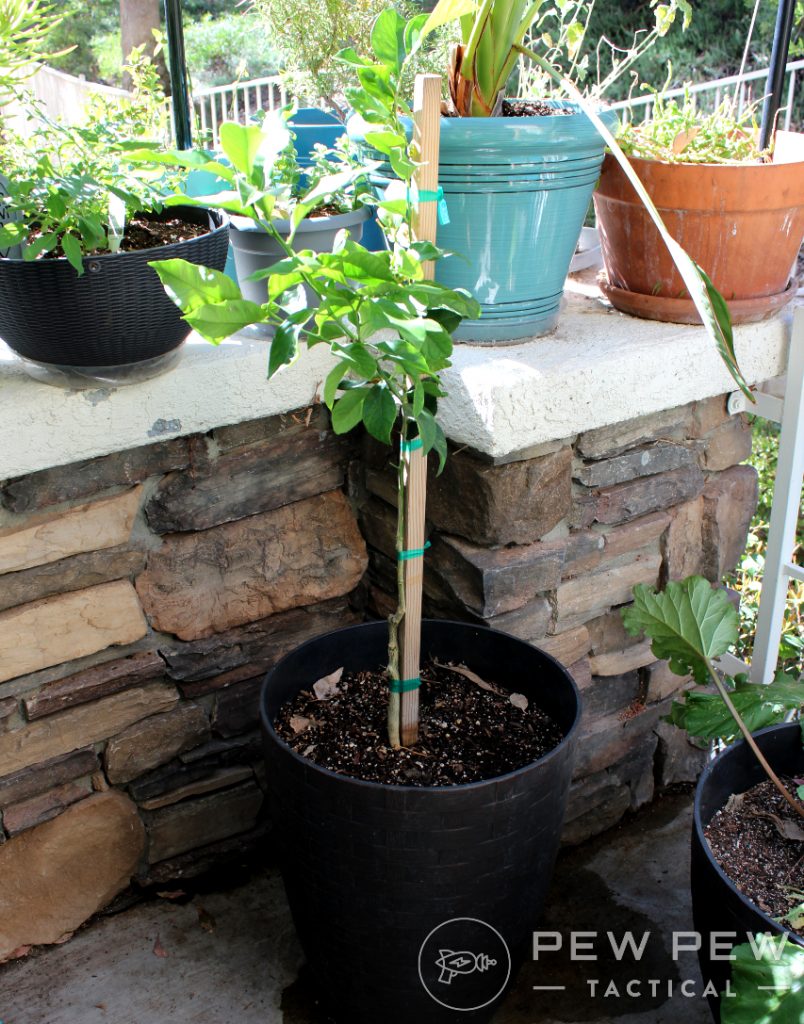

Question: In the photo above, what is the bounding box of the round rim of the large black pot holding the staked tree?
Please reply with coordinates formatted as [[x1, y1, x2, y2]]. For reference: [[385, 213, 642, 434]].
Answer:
[[259, 618, 582, 794]]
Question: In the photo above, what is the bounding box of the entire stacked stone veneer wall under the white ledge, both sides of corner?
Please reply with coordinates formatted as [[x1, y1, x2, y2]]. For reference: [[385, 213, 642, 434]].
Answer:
[[0, 391, 756, 959]]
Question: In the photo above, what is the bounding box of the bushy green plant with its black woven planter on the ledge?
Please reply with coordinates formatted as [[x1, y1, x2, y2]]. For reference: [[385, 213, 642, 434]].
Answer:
[[0, 45, 227, 384]]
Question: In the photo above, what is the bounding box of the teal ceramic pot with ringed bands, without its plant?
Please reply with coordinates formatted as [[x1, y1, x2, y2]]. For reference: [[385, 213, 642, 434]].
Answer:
[[347, 104, 617, 342]]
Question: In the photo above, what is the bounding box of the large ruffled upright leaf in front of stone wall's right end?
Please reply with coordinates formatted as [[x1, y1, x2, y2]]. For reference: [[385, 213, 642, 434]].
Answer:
[[623, 577, 739, 683]]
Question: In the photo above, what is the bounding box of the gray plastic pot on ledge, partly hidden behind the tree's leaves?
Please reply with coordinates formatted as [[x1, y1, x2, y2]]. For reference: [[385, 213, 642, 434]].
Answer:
[[229, 206, 371, 305]]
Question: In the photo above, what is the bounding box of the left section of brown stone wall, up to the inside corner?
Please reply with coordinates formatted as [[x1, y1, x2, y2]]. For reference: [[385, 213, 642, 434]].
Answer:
[[0, 407, 367, 959]]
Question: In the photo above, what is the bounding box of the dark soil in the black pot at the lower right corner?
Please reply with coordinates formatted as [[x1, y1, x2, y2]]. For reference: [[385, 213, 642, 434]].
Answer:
[[705, 777, 804, 938]]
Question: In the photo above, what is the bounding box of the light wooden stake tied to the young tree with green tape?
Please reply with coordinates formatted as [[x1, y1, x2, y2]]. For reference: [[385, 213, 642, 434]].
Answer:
[[399, 75, 441, 746]]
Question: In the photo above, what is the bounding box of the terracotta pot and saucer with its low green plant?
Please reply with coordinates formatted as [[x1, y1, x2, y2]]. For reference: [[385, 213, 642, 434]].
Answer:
[[594, 93, 804, 324]]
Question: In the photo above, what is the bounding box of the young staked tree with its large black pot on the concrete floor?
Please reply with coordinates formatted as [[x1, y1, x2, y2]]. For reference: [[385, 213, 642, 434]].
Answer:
[[147, 46, 580, 1024]]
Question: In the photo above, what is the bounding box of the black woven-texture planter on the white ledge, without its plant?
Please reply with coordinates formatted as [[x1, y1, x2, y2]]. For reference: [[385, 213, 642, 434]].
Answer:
[[0, 207, 228, 367]]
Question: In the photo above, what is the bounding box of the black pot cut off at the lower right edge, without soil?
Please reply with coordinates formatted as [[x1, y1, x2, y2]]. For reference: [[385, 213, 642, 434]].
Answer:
[[691, 722, 804, 1022]]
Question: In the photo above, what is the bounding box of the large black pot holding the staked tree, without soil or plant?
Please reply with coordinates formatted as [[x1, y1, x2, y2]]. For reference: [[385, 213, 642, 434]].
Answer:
[[260, 621, 580, 1024]]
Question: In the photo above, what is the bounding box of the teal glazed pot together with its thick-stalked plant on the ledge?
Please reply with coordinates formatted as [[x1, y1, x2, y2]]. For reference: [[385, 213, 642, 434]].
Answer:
[[344, 0, 689, 342]]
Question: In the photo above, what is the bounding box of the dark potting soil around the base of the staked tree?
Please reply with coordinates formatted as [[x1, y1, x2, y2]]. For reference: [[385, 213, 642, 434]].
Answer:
[[276, 665, 563, 786]]
